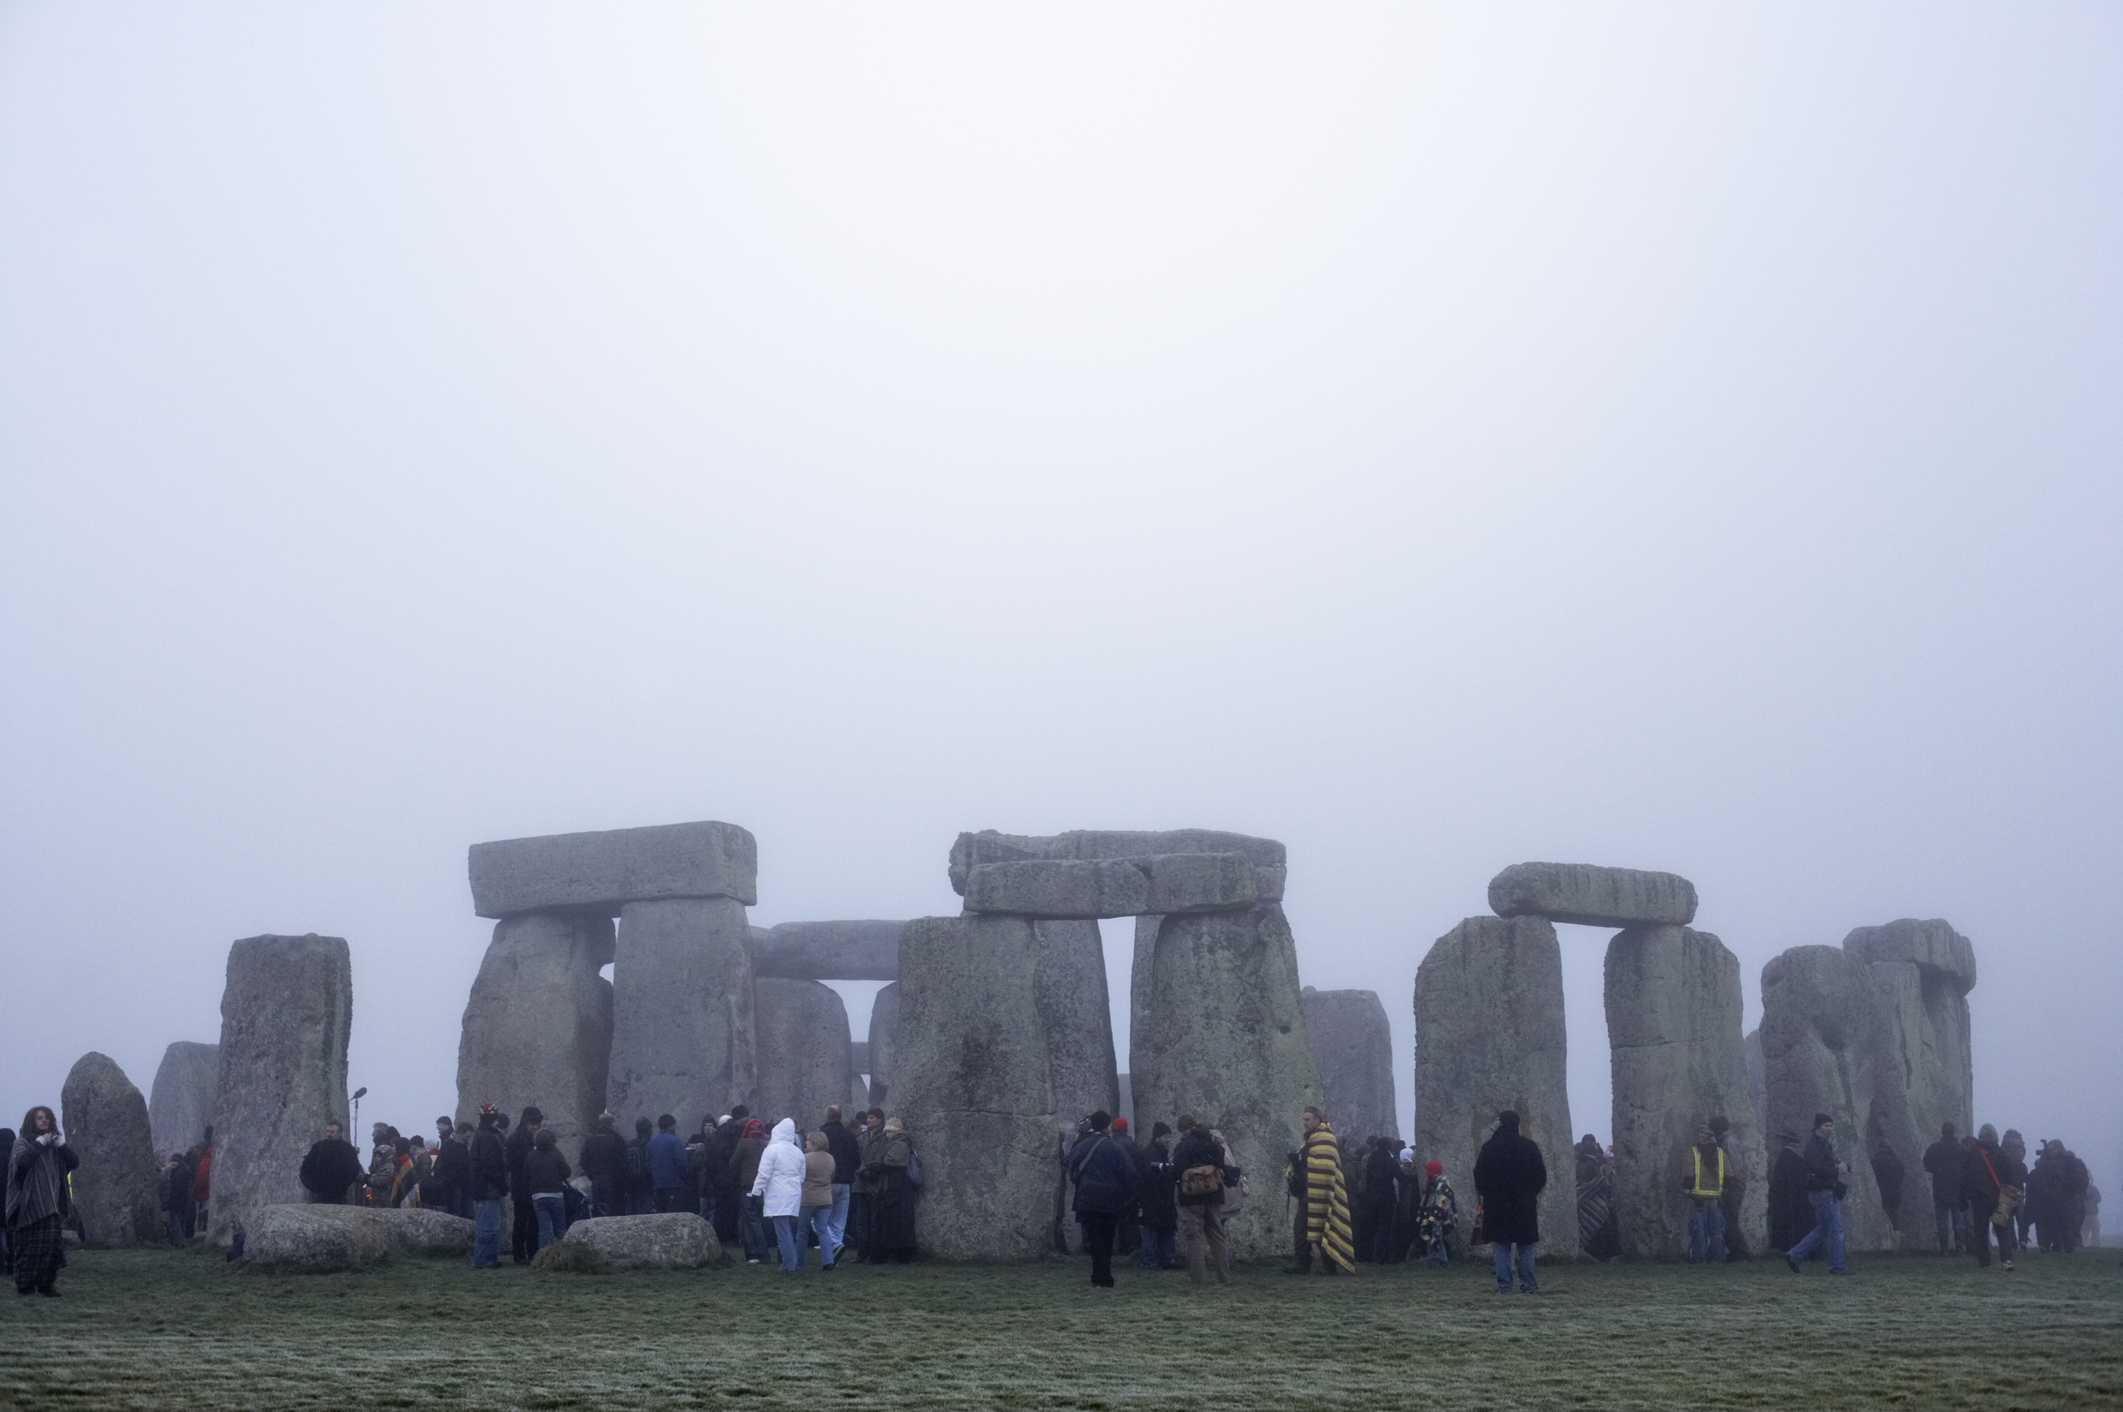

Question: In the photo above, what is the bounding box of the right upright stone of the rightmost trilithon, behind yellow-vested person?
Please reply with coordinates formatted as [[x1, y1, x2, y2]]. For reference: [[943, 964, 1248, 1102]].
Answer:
[[1607, 926, 1768, 1259]]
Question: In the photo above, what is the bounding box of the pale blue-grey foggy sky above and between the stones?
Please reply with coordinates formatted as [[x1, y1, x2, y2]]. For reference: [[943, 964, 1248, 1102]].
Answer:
[[0, 4, 2123, 1191]]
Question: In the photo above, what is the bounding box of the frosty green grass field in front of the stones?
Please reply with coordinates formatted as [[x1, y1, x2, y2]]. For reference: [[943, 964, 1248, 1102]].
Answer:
[[0, 1249, 2123, 1412]]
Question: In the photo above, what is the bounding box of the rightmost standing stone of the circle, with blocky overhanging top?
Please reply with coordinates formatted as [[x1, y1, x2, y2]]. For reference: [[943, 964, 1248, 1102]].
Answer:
[[1843, 917, 1977, 1155]]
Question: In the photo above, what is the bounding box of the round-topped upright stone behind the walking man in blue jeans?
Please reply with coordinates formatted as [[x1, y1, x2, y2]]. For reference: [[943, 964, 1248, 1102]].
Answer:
[[1762, 947, 1936, 1251]]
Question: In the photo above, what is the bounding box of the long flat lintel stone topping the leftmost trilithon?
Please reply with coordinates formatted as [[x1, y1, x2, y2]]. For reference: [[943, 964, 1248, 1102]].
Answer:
[[469, 820, 760, 917]]
